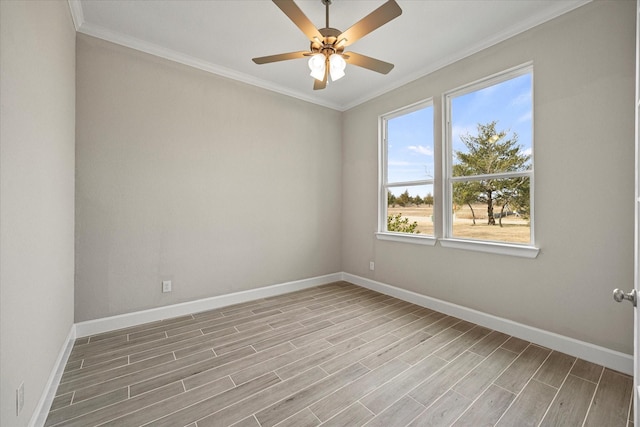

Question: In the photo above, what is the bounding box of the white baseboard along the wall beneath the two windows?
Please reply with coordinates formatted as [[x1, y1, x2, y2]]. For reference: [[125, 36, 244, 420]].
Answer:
[[342, 273, 633, 375]]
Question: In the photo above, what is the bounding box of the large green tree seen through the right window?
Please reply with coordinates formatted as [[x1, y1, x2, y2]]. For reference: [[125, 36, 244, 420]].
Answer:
[[453, 121, 531, 225]]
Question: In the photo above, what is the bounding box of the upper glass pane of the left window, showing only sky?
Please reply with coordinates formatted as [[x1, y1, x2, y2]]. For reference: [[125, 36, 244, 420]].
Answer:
[[387, 106, 434, 183]]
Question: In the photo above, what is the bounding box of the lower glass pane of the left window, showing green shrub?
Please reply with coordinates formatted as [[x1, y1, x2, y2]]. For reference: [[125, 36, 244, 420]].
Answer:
[[387, 185, 433, 236]]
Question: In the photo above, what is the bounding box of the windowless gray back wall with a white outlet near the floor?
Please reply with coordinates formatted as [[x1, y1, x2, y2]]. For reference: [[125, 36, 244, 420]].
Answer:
[[75, 34, 342, 321]]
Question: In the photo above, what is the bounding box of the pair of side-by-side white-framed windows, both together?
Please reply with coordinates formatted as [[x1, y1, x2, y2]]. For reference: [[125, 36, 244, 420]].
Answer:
[[377, 64, 538, 257]]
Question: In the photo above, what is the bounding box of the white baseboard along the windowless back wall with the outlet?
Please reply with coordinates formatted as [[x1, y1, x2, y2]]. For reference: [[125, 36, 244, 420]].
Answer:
[[76, 273, 342, 338]]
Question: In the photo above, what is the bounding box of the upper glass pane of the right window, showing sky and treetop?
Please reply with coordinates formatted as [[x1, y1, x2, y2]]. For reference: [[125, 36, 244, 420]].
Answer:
[[451, 73, 533, 176]]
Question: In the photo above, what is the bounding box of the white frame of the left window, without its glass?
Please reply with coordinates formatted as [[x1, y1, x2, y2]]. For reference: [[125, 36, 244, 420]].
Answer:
[[376, 98, 438, 246]]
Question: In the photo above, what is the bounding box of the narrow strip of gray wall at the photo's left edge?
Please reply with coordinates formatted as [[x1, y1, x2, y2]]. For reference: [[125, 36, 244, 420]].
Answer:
[[0, 1, 75, 427]]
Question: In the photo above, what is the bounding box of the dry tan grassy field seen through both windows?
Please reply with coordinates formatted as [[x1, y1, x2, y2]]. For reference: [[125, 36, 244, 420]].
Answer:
[[388, 205, 531, 243]]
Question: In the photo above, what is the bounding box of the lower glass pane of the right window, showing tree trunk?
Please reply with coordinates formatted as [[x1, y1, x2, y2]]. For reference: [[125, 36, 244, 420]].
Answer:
[[452, 177, 531, 244]]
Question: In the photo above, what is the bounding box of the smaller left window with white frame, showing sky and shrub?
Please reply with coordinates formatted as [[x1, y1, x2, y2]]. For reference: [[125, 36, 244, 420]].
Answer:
[[379, 101, 435, 243]]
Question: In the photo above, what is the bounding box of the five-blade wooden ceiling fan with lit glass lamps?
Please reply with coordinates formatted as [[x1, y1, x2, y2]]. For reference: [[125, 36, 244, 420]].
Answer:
[[253, 0, 402, 90]]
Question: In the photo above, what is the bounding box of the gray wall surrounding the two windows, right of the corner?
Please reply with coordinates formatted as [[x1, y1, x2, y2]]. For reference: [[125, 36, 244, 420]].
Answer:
[[342, 1, 635, 354]]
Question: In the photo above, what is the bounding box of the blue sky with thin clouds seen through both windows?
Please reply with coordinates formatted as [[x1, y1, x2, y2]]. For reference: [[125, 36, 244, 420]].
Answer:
[[387, 73, 533, 197]]
